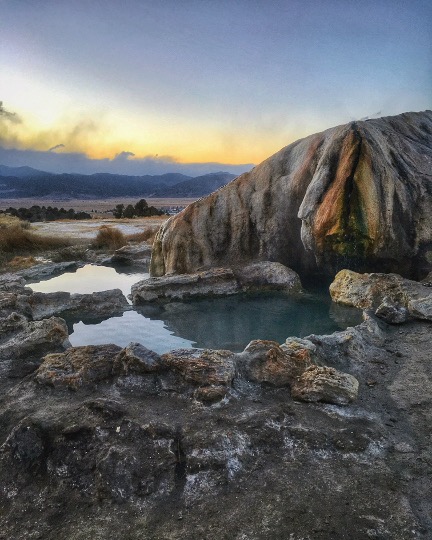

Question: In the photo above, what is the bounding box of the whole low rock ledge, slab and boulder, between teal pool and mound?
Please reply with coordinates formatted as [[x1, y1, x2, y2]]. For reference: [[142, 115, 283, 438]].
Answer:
[[131, 261, 301, 304]]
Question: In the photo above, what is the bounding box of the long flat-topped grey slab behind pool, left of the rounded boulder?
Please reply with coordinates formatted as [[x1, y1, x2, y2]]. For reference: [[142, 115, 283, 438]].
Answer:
[[131, 268, 240, 305]]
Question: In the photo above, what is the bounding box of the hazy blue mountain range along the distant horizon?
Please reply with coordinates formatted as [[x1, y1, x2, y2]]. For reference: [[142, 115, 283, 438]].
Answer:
[[0, 165, 235, 199]]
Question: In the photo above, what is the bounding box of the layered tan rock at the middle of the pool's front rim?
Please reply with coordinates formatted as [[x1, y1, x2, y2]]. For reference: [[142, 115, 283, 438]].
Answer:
[[161, 349, 234, 387]]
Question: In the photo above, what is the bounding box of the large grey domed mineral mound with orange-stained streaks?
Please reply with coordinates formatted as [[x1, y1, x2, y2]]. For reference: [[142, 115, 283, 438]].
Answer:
[[151, 111, 432, 276]]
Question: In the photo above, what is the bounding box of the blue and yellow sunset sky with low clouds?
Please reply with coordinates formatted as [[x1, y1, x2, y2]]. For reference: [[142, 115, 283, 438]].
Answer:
[[0, 0, 432, 174]]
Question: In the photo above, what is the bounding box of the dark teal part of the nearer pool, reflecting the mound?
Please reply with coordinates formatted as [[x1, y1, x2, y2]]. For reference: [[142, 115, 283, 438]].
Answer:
[[139, 293, 361, 351]]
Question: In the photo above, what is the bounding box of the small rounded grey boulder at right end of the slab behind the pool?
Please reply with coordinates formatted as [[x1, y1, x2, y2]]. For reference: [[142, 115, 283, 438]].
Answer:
[[234, 261, 302, 292]]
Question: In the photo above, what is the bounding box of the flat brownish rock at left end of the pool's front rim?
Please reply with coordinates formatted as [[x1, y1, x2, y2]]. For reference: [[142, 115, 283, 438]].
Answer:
[[35, 345, 121, 390]]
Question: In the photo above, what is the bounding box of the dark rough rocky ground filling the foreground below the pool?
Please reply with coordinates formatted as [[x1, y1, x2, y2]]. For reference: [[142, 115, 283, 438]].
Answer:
[[0, 317, 432, 540]]
